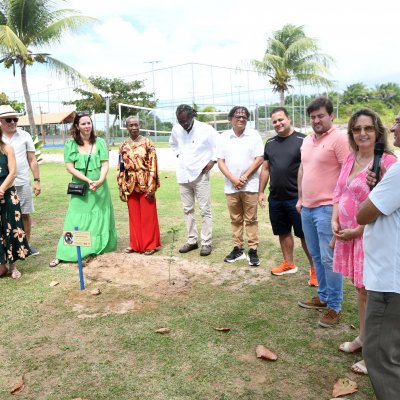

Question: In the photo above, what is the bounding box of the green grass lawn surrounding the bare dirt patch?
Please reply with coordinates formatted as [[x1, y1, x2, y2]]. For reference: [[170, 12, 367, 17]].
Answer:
[[0, 163, 374, 400]]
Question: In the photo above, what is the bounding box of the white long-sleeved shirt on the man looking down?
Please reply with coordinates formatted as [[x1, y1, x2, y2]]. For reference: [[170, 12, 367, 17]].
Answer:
[[169, 120, 218, 183]]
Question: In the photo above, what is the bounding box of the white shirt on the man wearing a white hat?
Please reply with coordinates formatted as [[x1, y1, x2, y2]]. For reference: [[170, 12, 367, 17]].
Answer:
[[3, 128, 35, 186]]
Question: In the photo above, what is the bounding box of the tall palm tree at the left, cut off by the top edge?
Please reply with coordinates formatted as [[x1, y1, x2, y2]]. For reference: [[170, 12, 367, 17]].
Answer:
[[0, 0, 96, 135]]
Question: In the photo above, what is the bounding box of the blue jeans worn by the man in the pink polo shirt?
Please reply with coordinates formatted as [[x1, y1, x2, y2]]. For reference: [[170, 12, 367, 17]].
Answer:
[[301, 205, 343, 312]]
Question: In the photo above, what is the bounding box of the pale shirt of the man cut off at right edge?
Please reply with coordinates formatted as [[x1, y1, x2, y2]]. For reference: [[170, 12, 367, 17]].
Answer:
[[363, 162, 400, 294]]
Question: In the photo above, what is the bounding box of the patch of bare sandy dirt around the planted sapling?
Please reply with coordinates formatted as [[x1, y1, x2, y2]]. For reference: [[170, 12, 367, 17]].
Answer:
[[69, 253, 270, 318]]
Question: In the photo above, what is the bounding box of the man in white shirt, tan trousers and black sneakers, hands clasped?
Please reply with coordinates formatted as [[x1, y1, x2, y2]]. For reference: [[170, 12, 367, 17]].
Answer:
[[217, 106, 264, 267]]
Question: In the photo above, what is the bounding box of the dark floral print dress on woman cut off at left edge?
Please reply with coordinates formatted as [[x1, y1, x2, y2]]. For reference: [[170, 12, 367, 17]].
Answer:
[[0, 152, 30, 264]]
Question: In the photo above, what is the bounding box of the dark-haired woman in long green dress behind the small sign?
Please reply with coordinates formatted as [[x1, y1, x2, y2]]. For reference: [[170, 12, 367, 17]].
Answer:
[[50, 113, 117, 267]]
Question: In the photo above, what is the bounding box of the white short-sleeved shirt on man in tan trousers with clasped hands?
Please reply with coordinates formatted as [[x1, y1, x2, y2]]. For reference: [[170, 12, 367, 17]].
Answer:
[[217, 127, 264, 194]]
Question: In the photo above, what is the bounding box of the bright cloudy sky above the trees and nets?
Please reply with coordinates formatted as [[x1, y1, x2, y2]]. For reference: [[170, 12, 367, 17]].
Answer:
[[0, 0, 400, 112]]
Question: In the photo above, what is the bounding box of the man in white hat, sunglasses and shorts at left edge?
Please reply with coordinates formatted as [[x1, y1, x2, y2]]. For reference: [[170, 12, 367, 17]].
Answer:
[[0, 105, 40, 256]]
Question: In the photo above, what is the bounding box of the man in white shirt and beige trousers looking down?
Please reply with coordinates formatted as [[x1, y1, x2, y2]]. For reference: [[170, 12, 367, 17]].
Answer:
[[169, 104, 218, 256]]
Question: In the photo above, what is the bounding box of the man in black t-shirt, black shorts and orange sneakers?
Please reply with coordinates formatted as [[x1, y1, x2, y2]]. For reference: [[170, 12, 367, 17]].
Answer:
[[258, 107, 318, 286]]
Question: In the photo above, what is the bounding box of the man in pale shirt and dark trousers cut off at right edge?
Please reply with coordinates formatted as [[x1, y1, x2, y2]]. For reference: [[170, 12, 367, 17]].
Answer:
[[357, 113, 400, 400]]
